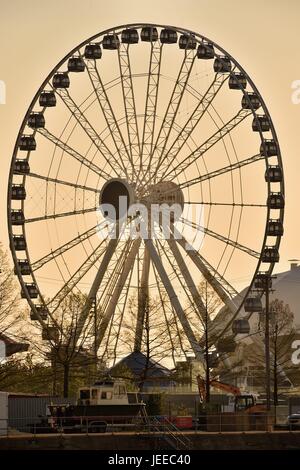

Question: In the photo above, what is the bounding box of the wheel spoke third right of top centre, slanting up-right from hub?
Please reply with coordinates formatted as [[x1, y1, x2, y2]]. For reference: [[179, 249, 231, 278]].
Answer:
[[156, 73, 229, 179]]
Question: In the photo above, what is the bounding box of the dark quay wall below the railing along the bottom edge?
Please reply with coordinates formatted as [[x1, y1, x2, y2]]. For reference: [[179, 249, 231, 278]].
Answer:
[[0, 431, 300, 451]]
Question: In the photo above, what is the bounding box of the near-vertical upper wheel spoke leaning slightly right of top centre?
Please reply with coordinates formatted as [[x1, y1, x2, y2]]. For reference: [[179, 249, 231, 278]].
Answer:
[[140, 41, 163, 168]]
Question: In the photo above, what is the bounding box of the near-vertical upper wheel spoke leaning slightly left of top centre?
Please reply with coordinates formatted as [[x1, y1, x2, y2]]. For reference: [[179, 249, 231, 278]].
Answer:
[[118, 43, 141, 166]]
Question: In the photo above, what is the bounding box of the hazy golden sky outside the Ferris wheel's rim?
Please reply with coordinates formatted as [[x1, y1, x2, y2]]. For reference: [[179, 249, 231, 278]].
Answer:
[[0, 0, 300, 282]]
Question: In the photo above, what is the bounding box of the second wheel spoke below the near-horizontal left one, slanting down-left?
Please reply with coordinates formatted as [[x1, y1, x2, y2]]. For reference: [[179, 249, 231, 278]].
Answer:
[[47, 239, 107, 314]]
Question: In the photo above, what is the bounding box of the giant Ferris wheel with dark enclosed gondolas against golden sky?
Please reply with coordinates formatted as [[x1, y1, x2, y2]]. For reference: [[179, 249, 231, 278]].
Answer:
[[7, 24, 284, 366]]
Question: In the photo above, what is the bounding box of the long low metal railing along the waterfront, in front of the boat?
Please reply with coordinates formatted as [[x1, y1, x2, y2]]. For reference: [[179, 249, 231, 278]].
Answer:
[[0, 413, 300, 438]]
